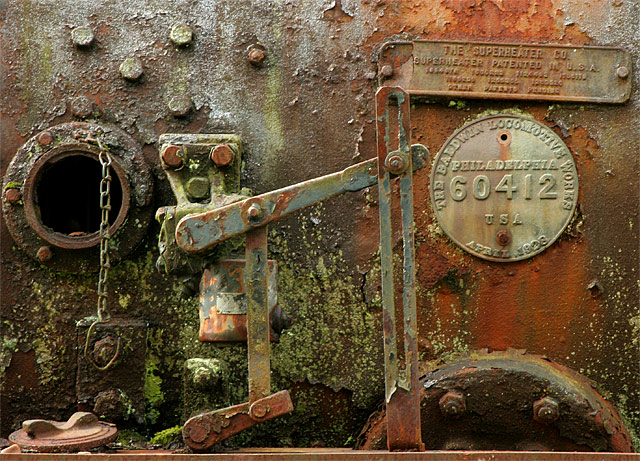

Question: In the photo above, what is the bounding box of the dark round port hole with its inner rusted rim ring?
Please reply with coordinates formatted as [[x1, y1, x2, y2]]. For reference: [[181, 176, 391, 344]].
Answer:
[[25, 150, 129, 248]]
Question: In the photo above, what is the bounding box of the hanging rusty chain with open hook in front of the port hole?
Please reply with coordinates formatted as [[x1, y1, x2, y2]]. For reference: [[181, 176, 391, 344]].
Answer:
[[84, 134, 120, 371]]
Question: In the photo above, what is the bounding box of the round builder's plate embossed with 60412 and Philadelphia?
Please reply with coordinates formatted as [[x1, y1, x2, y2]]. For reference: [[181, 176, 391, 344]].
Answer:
[[431, 114, 578, 262]]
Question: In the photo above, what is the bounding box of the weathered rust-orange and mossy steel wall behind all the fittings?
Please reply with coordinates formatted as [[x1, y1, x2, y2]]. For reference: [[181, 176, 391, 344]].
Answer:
[[0, 0, 640, 446]]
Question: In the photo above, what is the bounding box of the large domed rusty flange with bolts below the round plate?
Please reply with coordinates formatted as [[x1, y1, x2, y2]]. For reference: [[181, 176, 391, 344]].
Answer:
[[361, 350, 634, 453]]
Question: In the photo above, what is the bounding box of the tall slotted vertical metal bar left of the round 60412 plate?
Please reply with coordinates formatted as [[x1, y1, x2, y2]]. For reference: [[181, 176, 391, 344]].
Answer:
[[376, 87, 424, 450]]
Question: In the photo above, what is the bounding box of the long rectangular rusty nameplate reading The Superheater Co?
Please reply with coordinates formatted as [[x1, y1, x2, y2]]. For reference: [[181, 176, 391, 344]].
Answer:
[[379, 40, 632, 103]]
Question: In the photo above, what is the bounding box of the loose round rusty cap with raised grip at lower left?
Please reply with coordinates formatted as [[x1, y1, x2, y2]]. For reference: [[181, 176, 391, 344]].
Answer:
[[9, 412, 118, 453]]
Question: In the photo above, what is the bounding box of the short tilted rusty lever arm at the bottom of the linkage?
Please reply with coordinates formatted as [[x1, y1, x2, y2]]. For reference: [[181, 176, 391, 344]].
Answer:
[[182, 390, 293, 451]]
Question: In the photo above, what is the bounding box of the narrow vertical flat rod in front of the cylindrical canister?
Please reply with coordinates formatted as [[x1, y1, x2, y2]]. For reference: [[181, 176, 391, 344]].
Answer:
[[244, 225, 271, 403]]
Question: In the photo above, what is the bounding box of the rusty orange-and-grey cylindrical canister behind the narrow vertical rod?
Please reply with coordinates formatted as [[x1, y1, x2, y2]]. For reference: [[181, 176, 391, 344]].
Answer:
[[198, 259, 282, 341]]
